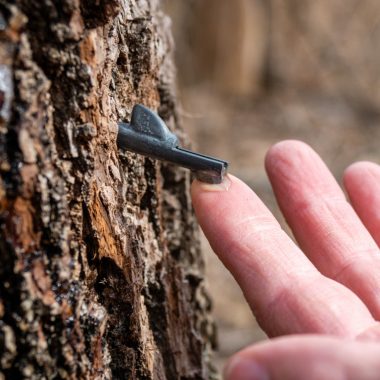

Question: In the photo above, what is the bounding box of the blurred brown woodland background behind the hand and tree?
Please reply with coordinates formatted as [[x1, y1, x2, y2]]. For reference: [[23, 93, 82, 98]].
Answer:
[[163, 0, 380, 372]]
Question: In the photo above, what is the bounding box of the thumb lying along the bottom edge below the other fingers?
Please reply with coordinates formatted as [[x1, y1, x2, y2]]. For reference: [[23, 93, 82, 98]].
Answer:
[[225, 335, 380, 380]]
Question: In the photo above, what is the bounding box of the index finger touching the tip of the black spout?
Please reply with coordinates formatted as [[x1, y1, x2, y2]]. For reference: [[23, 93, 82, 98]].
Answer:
[[192, 176, 374, 336]]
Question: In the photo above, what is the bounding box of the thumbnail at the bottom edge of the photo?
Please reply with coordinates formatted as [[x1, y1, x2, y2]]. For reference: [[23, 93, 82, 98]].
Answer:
[[223, 356, 270, 380]]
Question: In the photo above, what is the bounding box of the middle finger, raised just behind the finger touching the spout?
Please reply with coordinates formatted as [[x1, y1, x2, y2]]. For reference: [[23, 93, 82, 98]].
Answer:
[[266, 141, 380, 320]]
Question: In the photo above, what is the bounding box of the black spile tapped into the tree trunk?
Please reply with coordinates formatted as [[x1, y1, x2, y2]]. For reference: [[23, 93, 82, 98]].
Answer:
[[117, 104, 228, 183]]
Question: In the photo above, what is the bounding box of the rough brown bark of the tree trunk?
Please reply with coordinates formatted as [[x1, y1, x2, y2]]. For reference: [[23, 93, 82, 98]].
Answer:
[[0, 0, 214, 379]]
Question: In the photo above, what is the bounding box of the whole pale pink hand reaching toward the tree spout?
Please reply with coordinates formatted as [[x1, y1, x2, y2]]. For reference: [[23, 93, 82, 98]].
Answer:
[[192, 141, 380, 380]]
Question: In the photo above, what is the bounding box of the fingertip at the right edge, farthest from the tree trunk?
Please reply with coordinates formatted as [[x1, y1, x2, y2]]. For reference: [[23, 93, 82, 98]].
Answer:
[[344, 162, 380, 246]]
